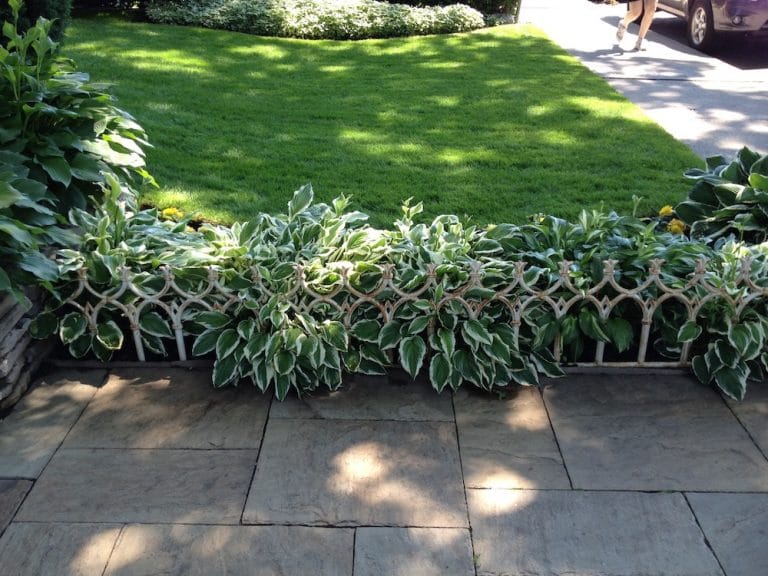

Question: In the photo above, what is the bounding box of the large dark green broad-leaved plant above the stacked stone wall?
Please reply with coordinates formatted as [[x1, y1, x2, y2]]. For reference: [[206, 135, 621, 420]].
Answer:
[[0, 0, 151, 299]]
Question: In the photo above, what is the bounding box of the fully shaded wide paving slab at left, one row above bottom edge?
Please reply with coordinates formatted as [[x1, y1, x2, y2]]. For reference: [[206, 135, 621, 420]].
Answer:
[[17, 448, 256, 524]]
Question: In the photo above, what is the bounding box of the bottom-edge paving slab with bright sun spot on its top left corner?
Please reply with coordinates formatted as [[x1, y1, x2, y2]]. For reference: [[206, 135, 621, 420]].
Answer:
[[467, 489, 724, 576]]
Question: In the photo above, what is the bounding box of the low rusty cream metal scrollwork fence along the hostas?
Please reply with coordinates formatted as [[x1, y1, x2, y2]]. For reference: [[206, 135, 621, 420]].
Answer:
[[64, 259, 768, 368]]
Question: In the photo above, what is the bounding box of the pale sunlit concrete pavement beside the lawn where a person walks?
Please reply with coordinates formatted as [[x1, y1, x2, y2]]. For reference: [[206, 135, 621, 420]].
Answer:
[[520, 0, 768, 158]]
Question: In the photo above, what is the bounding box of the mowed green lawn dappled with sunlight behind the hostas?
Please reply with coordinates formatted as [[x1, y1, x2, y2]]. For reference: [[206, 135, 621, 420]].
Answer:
[[65, 19, 701, 225]]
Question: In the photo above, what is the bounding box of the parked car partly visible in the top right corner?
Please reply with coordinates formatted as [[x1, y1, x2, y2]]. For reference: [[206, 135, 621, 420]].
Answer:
[[659, 0, 768, 52]]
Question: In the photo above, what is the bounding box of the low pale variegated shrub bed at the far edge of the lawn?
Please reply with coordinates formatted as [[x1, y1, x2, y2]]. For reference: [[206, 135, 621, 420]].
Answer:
[[147, 0, 485, 40]]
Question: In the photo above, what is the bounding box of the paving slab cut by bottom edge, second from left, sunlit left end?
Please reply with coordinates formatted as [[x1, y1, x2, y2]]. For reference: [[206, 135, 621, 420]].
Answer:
[[105, 525, 354, 576]]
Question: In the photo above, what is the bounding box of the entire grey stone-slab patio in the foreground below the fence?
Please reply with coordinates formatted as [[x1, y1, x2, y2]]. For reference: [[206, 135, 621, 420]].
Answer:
[[0, 368, 768, 576]]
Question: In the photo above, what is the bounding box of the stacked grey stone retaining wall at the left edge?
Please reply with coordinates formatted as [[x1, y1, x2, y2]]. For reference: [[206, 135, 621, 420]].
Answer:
[[0, 291, 51, 412]]
